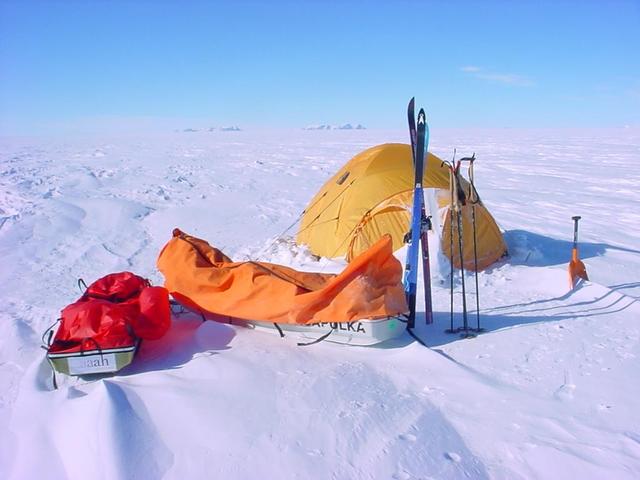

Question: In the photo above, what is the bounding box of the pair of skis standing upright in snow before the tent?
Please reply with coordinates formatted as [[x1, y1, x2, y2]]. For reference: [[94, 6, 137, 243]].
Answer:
[[403, 98, 433, 328]]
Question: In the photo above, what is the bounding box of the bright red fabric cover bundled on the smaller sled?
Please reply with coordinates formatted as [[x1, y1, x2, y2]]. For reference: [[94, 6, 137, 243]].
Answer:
[[49, 272, 171, 353]]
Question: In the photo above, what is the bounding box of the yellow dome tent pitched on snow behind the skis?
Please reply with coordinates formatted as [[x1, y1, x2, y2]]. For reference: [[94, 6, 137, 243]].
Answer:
[[296, 143, 507, 270]]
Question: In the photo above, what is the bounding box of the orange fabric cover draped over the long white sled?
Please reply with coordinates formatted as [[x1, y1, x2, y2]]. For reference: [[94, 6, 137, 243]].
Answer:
[[157, 229, 408, 324]]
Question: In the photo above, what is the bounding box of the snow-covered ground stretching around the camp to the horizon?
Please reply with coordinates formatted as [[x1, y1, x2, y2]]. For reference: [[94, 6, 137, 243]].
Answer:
[[0, 125, 640, 480]]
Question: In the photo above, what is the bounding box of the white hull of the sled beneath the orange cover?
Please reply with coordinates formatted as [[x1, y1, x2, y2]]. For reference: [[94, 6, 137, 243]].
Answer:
[[234, 315, 407, 345]]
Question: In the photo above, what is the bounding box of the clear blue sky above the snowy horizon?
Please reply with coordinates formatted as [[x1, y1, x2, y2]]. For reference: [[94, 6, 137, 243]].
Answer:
[[0, 0, 640, 134]]
